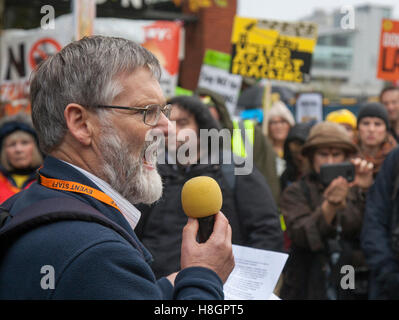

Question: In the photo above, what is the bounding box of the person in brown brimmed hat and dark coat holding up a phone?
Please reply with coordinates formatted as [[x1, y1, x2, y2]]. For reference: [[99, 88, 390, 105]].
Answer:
[[280, 122, 373, 299]]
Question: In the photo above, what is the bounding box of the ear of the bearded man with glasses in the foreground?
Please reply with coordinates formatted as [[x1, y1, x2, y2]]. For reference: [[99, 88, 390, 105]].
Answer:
[[64, 103, 93, 146]]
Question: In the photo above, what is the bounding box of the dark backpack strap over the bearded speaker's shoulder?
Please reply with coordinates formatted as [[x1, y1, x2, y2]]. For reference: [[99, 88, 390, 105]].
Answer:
[[0, 197, 144, 257]]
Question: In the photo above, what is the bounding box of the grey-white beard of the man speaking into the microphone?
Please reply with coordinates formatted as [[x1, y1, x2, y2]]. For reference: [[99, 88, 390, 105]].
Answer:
[[100, 124, 162, 204]]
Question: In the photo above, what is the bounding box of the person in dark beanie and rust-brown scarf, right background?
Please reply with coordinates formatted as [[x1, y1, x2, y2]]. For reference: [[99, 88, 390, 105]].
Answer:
[[355, 103, 397, 176]]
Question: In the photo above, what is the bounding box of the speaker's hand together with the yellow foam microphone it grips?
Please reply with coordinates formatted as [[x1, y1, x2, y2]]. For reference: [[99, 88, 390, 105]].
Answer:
[[180, 176, 234, 283]]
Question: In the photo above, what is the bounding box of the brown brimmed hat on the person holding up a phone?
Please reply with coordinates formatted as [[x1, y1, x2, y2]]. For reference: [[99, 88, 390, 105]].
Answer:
[[302, 121, 358, 156]]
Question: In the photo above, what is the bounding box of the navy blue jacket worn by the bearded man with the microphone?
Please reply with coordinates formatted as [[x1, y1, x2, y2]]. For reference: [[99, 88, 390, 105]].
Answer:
[[0, 157, 223, 300]]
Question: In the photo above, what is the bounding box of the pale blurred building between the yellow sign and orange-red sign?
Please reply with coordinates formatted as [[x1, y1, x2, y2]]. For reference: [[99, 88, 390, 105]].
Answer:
[[301, 5, 392, 97]]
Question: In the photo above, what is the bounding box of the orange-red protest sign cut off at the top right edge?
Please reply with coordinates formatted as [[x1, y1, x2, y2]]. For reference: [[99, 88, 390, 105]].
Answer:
[[377, 19, 399, 81]]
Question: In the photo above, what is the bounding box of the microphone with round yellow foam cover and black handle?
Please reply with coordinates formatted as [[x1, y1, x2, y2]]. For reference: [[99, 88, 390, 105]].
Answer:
[[181, 176, 223, 243]]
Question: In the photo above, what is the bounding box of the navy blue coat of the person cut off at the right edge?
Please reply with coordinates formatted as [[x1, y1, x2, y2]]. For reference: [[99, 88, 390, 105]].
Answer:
[[361, 148, 399, 299]]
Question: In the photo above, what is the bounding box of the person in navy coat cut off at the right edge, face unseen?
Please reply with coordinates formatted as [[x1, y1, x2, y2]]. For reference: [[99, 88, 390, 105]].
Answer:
[[361, 148, 399, 300]]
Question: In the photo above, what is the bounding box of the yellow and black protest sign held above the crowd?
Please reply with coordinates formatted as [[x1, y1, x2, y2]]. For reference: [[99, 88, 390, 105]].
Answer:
[[230, 16, 317, 82]]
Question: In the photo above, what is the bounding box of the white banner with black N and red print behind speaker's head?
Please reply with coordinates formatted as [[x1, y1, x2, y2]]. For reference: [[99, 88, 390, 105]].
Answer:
[[0, 15, 181, 117]]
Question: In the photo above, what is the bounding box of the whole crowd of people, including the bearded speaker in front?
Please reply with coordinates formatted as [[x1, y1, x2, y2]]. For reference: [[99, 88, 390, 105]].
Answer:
[[0, 36, 399, 300]]
